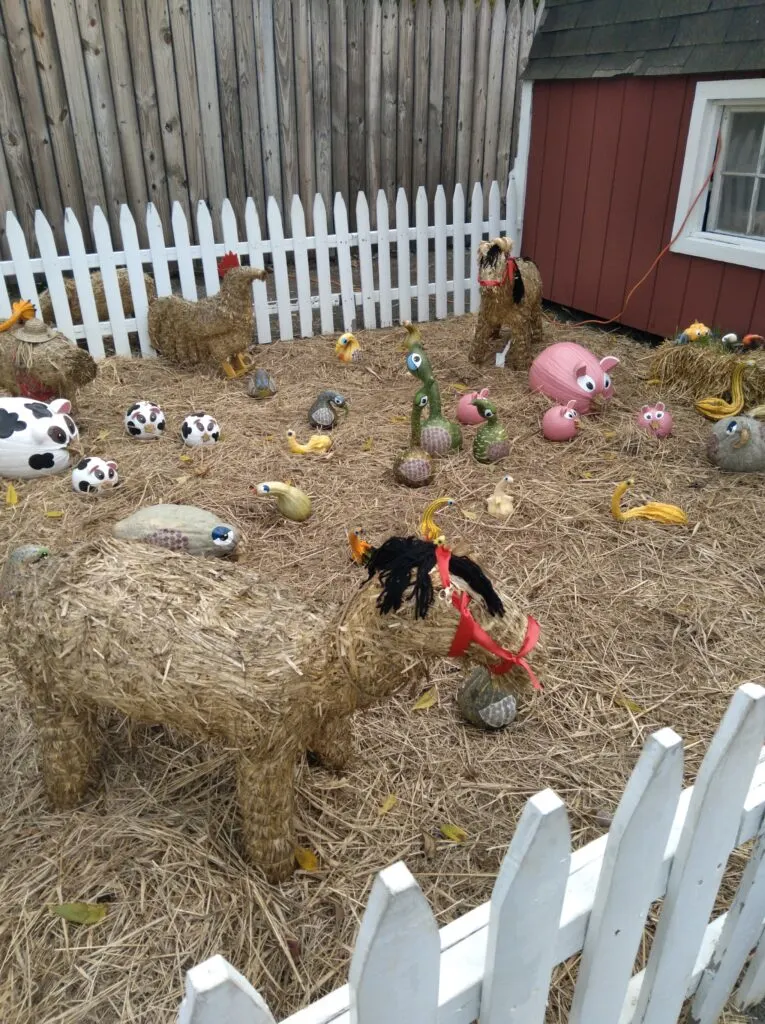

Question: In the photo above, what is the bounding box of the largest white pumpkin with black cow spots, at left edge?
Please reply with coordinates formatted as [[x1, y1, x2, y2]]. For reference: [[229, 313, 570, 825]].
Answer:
[[0, 397, 79, 480]]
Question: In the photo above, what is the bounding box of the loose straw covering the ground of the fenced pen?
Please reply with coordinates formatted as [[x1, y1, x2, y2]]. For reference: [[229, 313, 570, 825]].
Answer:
[[0, 316, 765, 1024]]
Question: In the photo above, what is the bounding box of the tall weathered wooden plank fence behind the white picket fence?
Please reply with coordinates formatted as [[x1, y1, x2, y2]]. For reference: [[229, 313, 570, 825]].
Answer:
[[0, 0, 543, 251]]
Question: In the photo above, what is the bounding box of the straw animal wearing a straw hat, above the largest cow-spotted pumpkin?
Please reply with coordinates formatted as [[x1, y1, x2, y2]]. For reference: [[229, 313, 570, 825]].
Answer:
[[0, 319, 96, 409]]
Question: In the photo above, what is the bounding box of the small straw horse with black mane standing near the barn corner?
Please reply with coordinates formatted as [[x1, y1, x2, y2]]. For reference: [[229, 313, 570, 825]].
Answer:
[[469, 238, 543, 370]]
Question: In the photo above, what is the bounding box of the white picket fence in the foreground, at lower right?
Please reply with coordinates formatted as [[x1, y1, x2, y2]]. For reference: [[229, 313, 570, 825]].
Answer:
[[178, 683, 765, 1024]]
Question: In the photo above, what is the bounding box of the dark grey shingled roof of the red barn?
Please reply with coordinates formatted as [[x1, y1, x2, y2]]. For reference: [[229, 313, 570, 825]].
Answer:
[[524, 0, 765, 79]]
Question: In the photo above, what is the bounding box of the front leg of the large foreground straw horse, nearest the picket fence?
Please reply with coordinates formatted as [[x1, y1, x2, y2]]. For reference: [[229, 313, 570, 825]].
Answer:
[[237, 748, 296, 883]]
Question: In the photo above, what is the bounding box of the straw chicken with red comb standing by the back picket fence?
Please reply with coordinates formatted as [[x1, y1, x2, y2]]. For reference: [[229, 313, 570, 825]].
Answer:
[[148, 266, 268, 368]]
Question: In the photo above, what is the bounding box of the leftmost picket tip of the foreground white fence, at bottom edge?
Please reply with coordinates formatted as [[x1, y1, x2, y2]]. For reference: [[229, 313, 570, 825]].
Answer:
[[178, 954, 273, 1024]]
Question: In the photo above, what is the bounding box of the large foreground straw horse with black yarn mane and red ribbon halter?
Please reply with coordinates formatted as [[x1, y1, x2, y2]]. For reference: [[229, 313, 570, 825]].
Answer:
[[0, 538, 533, 882]]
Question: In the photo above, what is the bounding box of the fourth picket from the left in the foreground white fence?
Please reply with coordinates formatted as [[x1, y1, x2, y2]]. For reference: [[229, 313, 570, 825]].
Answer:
[[568, 729, 683, 1024]]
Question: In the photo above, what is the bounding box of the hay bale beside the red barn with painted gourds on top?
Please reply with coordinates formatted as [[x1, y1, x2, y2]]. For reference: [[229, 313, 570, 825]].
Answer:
[[650, 341, 765, 408]]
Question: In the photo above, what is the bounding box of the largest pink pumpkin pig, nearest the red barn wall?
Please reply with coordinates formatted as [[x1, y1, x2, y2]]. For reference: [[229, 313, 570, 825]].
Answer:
[[528, 341, 619, 415]]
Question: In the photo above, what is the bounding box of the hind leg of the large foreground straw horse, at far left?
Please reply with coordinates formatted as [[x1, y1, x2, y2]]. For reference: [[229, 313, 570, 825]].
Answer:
[[33, 693, 100, 810]]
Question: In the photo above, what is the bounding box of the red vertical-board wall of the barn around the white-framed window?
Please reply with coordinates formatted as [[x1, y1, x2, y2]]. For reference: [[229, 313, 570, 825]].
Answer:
[[522, 76, 765, 337]]
